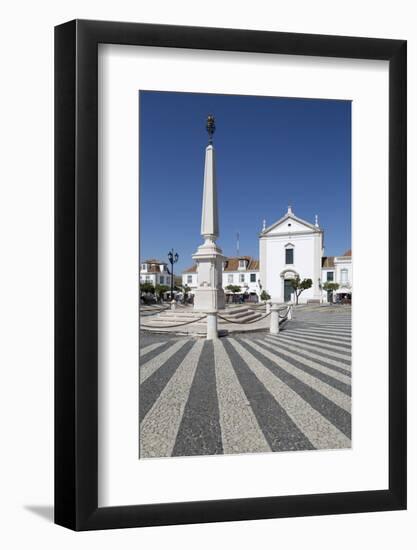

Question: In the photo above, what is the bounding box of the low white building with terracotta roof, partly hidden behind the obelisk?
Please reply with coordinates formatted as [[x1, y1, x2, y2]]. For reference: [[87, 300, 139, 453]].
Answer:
[[182, 256, 260, 296]]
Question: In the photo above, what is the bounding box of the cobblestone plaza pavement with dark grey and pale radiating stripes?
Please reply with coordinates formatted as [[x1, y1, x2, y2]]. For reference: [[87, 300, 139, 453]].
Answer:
[[139, 306, 351, 458]]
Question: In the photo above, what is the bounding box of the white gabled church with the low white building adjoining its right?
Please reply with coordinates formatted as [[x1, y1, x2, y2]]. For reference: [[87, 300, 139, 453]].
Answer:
[[259, 206, 352, 303]]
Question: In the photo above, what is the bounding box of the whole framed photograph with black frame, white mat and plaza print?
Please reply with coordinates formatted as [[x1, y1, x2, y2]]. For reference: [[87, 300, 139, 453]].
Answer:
[[55, 20, 406, 530]]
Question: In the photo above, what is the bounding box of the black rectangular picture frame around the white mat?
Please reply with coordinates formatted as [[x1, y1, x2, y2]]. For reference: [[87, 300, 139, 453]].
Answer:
[[55, 20, 407, 530]]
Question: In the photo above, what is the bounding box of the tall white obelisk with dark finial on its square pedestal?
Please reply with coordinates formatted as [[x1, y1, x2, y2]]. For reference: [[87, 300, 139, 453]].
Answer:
[[193, 115, 225, 312]]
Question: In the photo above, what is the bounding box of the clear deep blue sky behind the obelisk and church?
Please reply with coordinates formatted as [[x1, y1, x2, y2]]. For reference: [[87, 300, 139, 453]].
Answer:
[[139, 91, 351, 273]]
